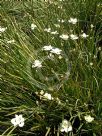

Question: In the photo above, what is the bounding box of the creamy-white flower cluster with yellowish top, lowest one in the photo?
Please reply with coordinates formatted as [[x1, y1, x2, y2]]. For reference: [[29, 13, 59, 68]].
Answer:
[[60, 119, 72, 133]]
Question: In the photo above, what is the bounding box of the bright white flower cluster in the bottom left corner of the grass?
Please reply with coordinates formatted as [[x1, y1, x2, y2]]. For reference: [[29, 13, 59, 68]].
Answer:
[[11, 115, 24, 127]]
